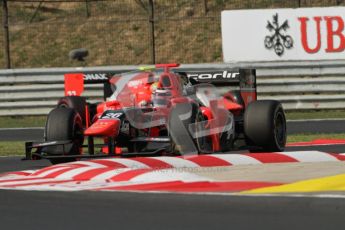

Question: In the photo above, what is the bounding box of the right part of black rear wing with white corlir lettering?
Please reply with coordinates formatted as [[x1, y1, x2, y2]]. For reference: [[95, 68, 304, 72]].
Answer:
[[175, 69, 257, 106]]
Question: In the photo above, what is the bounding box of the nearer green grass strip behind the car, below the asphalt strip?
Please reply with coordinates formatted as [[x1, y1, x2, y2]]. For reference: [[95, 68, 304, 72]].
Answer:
[[0, 133, 345, 157]]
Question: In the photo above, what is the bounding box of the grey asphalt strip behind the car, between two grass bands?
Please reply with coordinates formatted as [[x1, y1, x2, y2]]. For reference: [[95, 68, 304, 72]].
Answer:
[[0, 120, 345, 141]]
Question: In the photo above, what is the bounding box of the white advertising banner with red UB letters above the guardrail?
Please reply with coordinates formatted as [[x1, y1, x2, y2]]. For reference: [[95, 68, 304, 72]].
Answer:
[[222, 7, 345, 62]]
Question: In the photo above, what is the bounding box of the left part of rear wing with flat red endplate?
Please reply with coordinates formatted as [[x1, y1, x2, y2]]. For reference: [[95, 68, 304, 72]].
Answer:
[[64, 73, 113, 100]]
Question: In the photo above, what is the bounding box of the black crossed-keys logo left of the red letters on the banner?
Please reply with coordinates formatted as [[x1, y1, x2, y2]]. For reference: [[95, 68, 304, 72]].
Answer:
[[265, 14, 293, 57]]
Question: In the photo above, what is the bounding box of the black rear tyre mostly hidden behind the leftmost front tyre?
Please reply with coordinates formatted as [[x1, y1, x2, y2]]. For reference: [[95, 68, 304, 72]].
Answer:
[[57, 96, 86, 125]]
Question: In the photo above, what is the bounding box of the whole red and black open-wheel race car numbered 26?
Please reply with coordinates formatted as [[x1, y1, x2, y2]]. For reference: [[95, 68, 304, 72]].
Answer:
[[26, 64, 286, 164]]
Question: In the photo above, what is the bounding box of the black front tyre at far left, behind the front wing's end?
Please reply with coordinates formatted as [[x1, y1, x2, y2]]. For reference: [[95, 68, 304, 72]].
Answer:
[[45, 108, 84, 164]]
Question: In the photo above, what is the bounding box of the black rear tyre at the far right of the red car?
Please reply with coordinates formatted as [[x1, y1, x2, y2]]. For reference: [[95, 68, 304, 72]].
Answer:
[[244, 100, 286, 152]]
